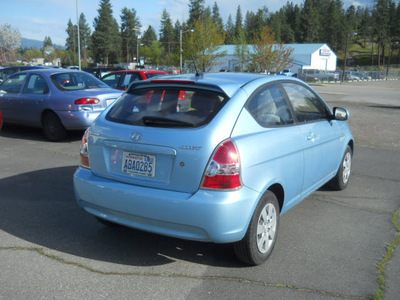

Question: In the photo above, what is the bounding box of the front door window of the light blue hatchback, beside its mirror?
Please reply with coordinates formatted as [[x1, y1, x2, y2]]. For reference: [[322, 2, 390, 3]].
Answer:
[[283, 83, 329, 123]]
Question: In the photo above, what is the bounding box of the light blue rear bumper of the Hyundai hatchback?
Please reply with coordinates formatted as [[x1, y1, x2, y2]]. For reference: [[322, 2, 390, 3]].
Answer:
[[74, 168, 260, 243]]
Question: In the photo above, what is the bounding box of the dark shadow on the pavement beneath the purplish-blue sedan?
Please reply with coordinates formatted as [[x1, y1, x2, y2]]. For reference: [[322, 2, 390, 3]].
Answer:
[[0, 124, 84, 142]]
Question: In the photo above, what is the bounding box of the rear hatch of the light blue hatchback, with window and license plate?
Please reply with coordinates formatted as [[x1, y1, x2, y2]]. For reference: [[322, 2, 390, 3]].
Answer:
[[89, 84, 239, 193]]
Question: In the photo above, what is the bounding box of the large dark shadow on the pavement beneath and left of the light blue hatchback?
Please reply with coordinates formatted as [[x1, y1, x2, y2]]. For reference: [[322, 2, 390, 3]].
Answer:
[[0, 166, 244, 268]]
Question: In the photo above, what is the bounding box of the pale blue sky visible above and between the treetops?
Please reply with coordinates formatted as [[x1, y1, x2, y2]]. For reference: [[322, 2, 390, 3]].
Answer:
[[0, 0, 380, 46]]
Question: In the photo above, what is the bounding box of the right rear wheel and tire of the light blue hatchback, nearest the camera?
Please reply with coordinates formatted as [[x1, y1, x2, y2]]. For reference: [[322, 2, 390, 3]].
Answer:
[[233, 191, 279, 266]]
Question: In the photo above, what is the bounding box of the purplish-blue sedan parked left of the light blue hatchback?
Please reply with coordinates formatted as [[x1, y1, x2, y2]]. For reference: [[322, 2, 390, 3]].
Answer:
[[0, 69, 122, 141]]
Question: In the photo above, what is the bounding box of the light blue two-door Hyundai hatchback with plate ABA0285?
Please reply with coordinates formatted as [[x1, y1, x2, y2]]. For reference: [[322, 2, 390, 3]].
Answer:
[[74, 73, 354, 265]]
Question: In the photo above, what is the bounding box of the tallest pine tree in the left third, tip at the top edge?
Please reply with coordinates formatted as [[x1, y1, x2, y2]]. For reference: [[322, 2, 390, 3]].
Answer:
[[92, 0, 121, 65]]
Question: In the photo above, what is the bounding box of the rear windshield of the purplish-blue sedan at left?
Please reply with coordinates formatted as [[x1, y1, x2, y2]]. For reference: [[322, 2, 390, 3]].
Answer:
[[50, 72, 109, 91]]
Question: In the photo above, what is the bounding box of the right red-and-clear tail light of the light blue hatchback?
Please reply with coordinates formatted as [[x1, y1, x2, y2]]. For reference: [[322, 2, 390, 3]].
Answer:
[[201, 140, 242, 190]]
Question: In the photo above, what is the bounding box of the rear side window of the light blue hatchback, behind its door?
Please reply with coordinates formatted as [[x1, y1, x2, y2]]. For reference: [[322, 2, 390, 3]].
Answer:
[[247, 84, 294, 127]]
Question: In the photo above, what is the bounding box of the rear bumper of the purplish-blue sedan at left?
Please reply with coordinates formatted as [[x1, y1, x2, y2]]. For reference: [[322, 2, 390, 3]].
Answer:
[[57, 110, 102, 130]]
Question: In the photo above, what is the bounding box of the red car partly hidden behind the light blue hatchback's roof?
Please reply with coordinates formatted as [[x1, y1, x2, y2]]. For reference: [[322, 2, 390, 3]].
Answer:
[[101, 70, 169, 90]]
